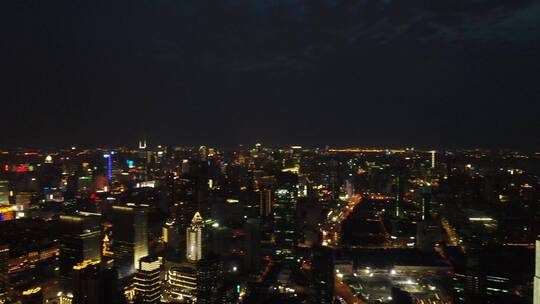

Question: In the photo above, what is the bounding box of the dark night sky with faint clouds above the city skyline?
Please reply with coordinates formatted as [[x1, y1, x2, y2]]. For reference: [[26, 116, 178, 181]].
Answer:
[[0, 0, 540, 149]]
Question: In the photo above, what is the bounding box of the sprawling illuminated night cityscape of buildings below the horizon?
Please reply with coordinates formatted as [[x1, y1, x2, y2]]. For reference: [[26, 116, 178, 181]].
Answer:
[[0, 144, 540, 304]]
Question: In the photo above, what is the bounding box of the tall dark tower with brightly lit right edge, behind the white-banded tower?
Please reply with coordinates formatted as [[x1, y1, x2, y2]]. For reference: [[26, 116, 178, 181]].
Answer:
[[111, 206, 148, 278]]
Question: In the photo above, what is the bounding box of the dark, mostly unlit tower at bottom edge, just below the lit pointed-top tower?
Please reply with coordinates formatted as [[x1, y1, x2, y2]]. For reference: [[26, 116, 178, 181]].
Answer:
[[196, 255, 223, 304]]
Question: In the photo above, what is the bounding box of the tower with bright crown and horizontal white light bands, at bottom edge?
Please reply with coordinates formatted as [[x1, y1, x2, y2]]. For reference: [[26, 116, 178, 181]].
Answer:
[[133, 256, 161, 303]]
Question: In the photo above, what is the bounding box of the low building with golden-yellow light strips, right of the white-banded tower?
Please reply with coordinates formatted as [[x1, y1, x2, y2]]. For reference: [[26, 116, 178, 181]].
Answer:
[[164, 263, 197, 303]]
